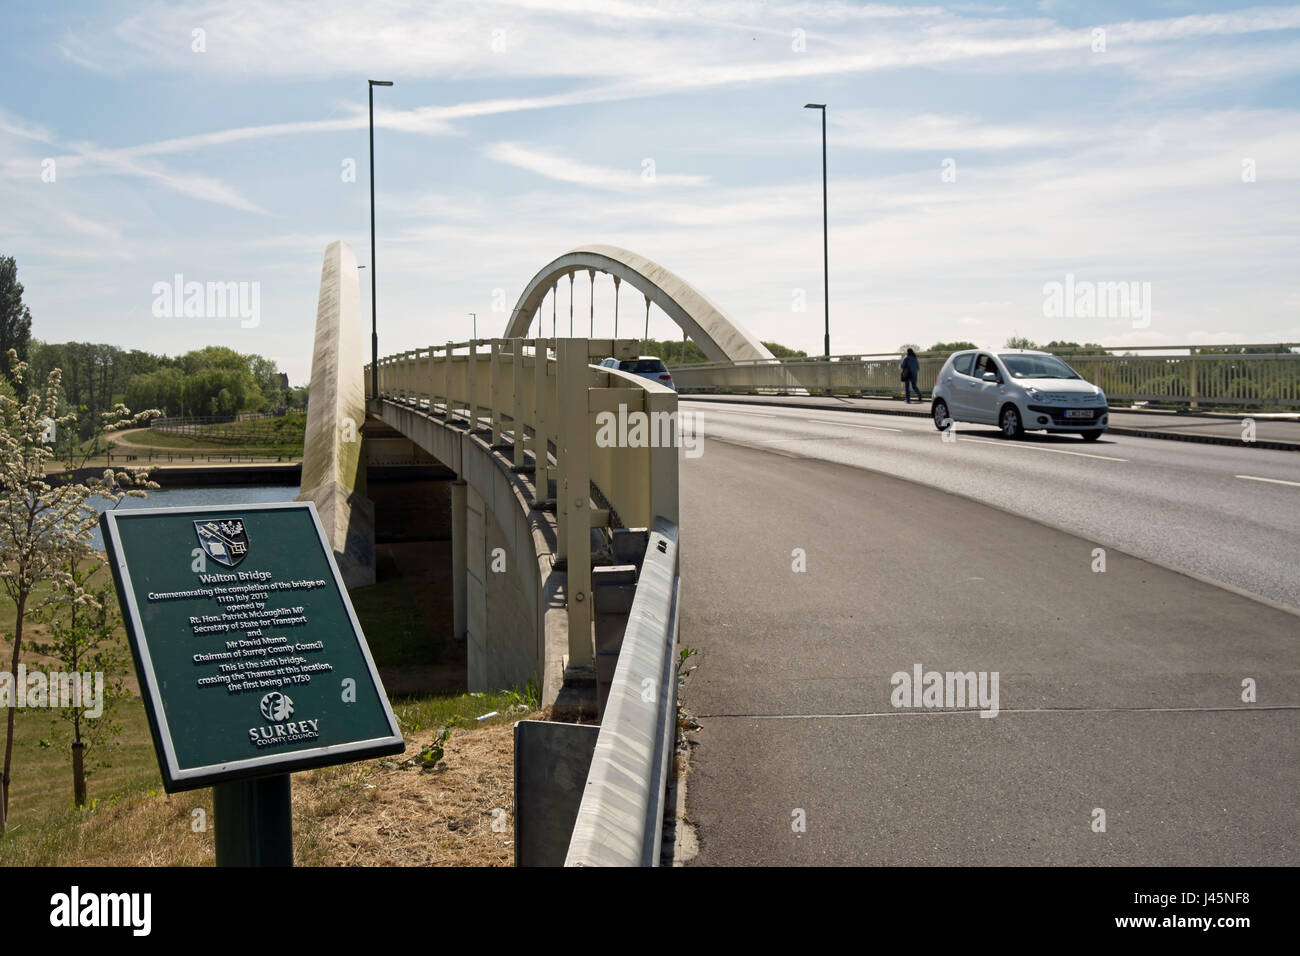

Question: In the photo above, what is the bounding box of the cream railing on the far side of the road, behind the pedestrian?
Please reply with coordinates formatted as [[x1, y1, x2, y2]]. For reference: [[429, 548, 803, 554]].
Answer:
[[673, 345, 1300, 408]]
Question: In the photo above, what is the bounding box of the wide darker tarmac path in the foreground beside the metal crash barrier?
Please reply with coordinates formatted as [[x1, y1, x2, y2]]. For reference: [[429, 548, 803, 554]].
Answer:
[[681, 441, 1300, 865]]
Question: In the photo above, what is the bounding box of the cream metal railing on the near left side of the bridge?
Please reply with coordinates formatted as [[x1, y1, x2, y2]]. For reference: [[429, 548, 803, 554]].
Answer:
[[365, 338, 680, 667]]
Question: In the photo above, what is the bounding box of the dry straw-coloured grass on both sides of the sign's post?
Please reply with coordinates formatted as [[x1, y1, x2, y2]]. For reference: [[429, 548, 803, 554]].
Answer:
[[12, 721, 515, 866]]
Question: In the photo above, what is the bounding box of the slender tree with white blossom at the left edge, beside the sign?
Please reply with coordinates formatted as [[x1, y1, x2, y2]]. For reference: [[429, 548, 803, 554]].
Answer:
[[0, 349, 157, 835]]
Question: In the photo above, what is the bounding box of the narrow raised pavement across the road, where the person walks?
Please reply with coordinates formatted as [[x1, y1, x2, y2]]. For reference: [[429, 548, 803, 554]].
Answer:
[[681, 394, 1300, 451]]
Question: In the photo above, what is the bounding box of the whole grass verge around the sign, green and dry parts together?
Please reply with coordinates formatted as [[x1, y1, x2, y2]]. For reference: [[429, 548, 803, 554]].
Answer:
[[0, 546, 536, 866]]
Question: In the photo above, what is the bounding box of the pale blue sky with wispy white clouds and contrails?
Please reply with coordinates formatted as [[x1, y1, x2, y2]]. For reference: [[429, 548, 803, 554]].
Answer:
[[0, 0, 1300, 385]]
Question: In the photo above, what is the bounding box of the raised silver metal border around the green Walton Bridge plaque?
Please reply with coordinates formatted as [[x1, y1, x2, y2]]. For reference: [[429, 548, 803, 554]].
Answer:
[[99, 501, 406, 793]]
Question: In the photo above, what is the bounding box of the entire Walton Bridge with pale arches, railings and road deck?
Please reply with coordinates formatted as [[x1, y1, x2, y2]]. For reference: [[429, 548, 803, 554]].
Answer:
[[303, 243, 1300, 865]]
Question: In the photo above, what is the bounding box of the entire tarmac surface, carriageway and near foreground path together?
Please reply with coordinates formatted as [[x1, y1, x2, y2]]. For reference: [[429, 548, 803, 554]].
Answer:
[[681, 405, 1300, 865]]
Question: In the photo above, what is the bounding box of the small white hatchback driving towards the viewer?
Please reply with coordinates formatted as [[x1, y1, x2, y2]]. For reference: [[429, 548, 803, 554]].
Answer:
[[930, 349, 1110, 441]]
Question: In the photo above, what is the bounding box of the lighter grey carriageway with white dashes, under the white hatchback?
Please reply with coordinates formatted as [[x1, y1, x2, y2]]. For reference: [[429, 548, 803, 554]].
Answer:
[[683, 401, 1300, 607]]
